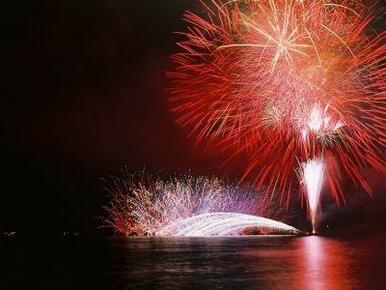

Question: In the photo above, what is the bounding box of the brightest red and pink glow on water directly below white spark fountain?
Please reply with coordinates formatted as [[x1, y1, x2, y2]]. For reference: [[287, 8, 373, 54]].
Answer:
[[296, 236, 360, 290]]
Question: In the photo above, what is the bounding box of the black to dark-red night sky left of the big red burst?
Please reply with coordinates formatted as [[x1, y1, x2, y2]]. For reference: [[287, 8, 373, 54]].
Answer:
[[0, 0, 386, 232]]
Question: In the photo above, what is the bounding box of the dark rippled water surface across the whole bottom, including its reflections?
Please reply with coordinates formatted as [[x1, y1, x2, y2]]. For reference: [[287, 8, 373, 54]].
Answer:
[[1, 236, 386, 290]]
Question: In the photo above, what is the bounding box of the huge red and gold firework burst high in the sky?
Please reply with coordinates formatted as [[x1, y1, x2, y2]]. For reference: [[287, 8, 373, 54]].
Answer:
[[169, 0, 386, 231]]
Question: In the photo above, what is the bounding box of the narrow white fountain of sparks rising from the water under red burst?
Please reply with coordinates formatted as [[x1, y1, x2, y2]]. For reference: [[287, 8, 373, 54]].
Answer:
[[302, 159, 325, 233]]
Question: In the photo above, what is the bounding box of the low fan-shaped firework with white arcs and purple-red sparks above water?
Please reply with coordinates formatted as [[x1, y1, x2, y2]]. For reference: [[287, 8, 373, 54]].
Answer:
[[106, 174, 299, 236]]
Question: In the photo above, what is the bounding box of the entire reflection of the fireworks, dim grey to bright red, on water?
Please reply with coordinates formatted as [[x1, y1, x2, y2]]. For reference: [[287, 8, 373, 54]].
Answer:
[[110, 236, 386, 290]]
